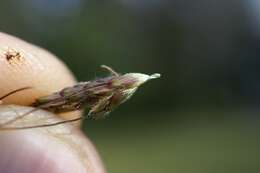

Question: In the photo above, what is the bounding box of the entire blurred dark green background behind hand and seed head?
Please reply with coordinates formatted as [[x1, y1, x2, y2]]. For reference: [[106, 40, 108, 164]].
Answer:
[[0, 0, 260, 173]]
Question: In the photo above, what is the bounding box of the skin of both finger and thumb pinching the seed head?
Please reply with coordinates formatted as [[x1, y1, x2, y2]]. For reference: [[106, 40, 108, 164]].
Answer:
[[0, 33, 106, 173]]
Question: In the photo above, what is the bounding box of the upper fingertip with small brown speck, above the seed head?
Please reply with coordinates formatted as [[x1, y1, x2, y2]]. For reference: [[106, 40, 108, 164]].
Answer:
[[0, 32, 80, 121]]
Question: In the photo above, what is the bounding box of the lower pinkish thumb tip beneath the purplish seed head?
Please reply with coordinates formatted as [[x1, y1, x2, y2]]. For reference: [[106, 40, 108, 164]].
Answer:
[[0, 105, 105, 173]]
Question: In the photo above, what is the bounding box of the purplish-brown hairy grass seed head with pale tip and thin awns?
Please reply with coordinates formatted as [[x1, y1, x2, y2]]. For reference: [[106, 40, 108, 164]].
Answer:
[[0, 65, 161, 130]]
